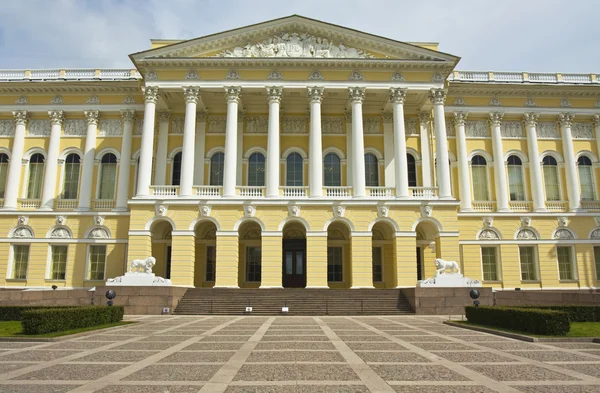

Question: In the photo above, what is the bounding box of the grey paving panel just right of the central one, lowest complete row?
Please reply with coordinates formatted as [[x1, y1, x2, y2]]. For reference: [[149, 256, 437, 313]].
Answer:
[[370, 364, 470, 381]]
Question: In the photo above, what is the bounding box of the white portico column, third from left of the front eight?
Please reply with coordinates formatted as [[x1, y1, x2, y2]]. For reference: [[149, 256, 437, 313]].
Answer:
[[223, 86, 242, 197]]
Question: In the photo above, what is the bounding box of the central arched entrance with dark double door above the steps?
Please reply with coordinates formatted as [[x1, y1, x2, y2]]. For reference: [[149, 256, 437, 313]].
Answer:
[[281, 221, 306, 288]]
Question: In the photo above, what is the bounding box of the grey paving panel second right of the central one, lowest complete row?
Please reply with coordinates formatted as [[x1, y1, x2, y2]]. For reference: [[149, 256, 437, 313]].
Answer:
[[465, 364, 576, 381]]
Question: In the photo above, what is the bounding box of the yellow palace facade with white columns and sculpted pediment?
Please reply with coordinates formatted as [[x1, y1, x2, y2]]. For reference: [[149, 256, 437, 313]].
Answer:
[[0, 15, 600, 289]]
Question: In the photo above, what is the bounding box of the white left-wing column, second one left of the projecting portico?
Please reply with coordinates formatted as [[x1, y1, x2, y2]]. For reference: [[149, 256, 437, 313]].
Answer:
[[77, 111, 99, 211]]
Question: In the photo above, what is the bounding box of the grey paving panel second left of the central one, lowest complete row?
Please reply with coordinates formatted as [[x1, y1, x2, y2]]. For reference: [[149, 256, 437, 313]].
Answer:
[[15, 364, 126, 380]]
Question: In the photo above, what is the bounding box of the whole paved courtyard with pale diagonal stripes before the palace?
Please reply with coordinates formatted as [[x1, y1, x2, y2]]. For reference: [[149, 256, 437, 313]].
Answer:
[[0, 316, 600, 393]]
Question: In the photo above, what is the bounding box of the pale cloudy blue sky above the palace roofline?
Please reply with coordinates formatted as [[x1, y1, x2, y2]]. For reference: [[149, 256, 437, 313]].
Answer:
[[0, 0, 600, 73]]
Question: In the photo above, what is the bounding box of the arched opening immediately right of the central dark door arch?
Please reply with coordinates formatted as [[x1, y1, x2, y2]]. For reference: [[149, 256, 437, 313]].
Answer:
[[327, 221, 352, 289]]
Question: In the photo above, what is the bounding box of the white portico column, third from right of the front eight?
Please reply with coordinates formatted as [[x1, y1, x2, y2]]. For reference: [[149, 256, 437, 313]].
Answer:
[[348, 87, 366, 198]]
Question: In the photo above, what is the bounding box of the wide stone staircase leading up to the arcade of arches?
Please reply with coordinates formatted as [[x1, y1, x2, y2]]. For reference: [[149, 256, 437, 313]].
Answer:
[[174, 288, 413, 315]]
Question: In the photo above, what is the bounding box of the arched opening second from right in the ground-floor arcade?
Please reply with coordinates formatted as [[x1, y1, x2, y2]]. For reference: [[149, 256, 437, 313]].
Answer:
[[371, 221, 397, 288]]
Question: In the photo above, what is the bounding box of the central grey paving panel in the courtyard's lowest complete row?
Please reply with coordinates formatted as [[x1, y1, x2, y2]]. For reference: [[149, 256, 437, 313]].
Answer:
[[234, 364, 359, 381]]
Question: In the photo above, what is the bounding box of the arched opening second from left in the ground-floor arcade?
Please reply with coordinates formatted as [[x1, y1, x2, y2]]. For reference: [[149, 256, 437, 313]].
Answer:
[[194, 220, 217, 288]]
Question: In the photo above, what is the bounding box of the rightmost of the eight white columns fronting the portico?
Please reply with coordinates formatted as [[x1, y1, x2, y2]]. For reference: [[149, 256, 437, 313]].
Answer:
[[429, 89, 452, 199]]
